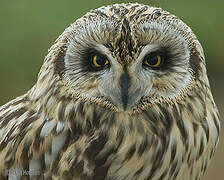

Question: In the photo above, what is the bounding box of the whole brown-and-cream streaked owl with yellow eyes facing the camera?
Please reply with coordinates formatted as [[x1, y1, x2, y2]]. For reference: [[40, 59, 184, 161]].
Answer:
[[0, 3, 220, 180]]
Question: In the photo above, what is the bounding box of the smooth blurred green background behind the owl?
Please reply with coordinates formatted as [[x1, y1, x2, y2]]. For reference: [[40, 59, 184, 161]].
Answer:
[[0, 0, 224, 180]]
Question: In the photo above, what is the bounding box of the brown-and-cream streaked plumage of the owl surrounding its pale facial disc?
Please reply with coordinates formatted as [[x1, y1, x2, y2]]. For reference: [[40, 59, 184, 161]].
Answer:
[[0, 3, 220, 180]]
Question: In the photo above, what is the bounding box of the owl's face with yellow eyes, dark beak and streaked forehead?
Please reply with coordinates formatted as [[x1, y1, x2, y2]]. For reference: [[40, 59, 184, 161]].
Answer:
[[60, 4, 193, 111]]
